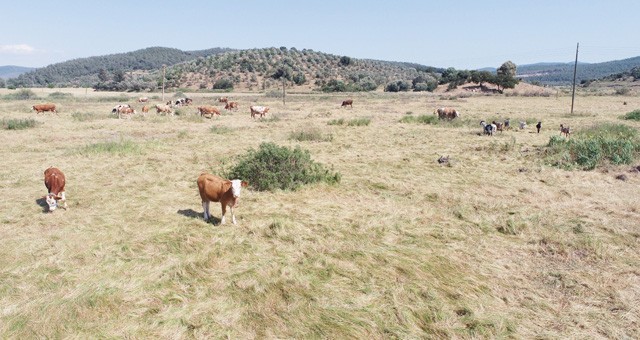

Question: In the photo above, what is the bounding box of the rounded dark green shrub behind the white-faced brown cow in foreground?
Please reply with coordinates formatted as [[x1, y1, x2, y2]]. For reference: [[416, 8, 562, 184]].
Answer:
[[227, 143, 341, 191]]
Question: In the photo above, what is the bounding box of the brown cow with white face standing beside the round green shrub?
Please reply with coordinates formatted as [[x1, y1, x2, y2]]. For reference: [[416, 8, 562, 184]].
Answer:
[[197, 172, 248, 224]]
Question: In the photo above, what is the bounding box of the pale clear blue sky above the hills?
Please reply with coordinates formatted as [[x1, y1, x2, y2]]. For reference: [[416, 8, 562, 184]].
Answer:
[[0, 0, 640, 69]]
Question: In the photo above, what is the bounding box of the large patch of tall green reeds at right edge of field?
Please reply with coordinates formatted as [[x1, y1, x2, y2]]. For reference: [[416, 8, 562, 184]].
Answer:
[[546, 124, 640, 170]]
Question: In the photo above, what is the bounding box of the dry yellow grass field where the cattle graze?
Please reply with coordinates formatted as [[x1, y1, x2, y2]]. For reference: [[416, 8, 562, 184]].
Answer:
[[0, 89, 640, 339]]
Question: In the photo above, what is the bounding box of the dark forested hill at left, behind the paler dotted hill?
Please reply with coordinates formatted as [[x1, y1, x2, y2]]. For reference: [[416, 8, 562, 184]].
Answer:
[[7, 47, 229, 87]]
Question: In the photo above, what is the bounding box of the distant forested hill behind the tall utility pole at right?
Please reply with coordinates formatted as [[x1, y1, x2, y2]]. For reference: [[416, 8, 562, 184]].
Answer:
[[517, 57, 640, 85]]
